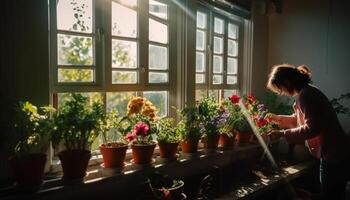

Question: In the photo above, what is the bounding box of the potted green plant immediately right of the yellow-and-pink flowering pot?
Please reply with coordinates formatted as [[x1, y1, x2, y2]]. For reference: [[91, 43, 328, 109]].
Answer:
[[157, 118, 180, 160]]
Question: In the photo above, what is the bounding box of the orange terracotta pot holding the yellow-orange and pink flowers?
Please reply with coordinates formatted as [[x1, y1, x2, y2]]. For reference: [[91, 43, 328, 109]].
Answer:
[[131, 143, 156, 164]]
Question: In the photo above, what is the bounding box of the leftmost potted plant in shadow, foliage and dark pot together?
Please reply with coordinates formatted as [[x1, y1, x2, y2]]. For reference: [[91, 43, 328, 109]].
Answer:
[[9, 102, 53, 192]]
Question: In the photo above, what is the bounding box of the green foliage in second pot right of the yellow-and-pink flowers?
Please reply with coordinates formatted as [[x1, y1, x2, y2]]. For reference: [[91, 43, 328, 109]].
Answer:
[[176, 107, 202, 140]]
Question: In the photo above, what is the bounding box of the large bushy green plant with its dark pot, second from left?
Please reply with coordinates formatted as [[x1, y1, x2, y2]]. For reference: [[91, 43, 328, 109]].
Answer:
[[51, 94, 104, 181]]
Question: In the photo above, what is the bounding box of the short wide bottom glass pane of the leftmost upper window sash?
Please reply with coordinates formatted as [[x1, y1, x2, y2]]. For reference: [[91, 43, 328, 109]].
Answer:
[[58, 69, 94, 83]]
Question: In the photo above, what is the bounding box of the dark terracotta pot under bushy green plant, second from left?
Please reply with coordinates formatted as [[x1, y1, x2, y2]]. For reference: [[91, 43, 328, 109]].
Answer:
[[58, 149, 91, 181]]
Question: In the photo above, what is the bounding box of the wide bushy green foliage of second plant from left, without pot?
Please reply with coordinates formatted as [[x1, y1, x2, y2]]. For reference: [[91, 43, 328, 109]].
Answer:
[[51, 93, 105, 150]]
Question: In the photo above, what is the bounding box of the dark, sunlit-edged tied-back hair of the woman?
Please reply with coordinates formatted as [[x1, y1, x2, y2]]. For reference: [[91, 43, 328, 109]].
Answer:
[[267, 64, 311, 93]]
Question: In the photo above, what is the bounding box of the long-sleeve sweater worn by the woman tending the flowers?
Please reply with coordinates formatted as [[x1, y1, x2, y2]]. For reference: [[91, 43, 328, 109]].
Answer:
[[281, 85, 350, 161]]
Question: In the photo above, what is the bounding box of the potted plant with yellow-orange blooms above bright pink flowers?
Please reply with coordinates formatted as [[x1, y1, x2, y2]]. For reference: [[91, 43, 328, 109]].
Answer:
[[123, 97, 157, 164]]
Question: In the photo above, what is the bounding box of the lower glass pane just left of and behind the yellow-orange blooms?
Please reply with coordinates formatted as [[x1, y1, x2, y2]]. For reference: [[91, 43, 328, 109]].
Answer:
[[107, 92, 136, 116]]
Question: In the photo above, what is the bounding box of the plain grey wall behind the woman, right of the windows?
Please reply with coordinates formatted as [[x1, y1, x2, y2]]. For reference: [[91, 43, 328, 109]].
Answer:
[[262, 0, 350, 132]]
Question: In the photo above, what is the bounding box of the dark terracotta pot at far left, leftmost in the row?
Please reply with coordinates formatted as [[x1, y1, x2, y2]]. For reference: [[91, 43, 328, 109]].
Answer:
[[9, 153, 46, 192]]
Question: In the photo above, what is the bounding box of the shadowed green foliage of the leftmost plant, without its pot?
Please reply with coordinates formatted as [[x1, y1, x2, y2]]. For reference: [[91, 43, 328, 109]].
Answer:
[[14, 101, 54, 156]]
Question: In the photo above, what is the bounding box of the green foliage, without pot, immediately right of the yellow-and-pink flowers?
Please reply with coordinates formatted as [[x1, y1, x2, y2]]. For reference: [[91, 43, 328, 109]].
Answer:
[[157, 118, 180, 143]]
